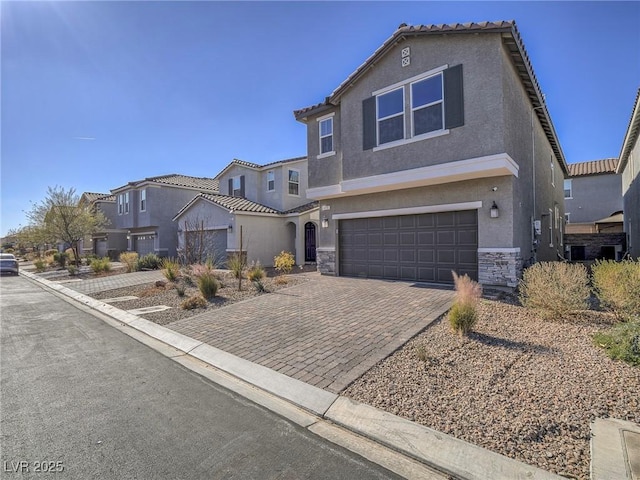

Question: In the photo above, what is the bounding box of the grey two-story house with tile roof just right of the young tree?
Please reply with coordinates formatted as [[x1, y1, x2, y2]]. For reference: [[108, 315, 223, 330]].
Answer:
[[111, 174, 218, 257]]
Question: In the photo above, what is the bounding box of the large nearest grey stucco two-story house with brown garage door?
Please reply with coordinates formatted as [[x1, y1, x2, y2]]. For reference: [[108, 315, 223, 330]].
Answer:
[[294, 22, 568, 286]]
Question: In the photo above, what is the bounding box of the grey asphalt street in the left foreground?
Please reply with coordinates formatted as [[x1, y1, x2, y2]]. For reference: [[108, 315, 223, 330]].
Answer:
[[0, 277, 398, 480]]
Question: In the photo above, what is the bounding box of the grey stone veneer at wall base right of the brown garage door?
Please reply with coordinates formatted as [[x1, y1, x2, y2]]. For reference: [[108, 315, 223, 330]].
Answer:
[[478, 248, 522, 287]]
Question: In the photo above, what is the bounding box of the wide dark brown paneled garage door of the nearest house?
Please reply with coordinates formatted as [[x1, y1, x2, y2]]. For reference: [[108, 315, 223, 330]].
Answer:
[[338, 210, 478, 283]]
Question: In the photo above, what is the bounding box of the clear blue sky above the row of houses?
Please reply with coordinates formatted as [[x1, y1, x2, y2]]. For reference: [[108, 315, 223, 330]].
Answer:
[[0, 1, 640, 235]]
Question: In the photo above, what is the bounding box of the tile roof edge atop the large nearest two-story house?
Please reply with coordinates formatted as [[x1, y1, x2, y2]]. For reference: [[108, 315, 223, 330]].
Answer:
[[293, 20, 568, 173]]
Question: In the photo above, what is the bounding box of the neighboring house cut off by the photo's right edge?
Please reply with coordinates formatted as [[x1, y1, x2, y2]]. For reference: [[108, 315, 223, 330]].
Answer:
[[617, 89, 640, 259]]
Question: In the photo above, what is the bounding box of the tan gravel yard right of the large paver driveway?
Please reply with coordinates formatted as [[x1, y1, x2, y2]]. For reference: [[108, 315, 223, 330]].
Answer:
[[342, 300, 640, 480]]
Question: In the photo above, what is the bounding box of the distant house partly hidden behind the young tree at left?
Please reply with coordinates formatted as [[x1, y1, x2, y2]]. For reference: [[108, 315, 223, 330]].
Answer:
[[79, 192, 127, 260]]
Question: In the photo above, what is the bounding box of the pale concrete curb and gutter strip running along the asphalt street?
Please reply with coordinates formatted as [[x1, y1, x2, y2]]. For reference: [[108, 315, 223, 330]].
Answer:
[[23, 272, 600, 480]]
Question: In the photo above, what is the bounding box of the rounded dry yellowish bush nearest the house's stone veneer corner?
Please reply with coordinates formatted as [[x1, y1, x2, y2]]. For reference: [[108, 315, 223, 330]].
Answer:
[[519, 262, 591, 319]]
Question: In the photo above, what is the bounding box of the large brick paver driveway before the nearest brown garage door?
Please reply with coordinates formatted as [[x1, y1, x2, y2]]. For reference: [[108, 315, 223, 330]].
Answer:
[[166, 274, 453, 393]]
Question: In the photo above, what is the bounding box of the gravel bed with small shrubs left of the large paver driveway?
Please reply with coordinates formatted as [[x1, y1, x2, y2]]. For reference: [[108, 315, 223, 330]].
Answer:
[[91, 273, 308, 325]]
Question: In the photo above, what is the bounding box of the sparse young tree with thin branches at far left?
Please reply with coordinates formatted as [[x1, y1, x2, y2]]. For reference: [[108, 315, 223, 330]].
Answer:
[[27, 186, 109, 266]]
